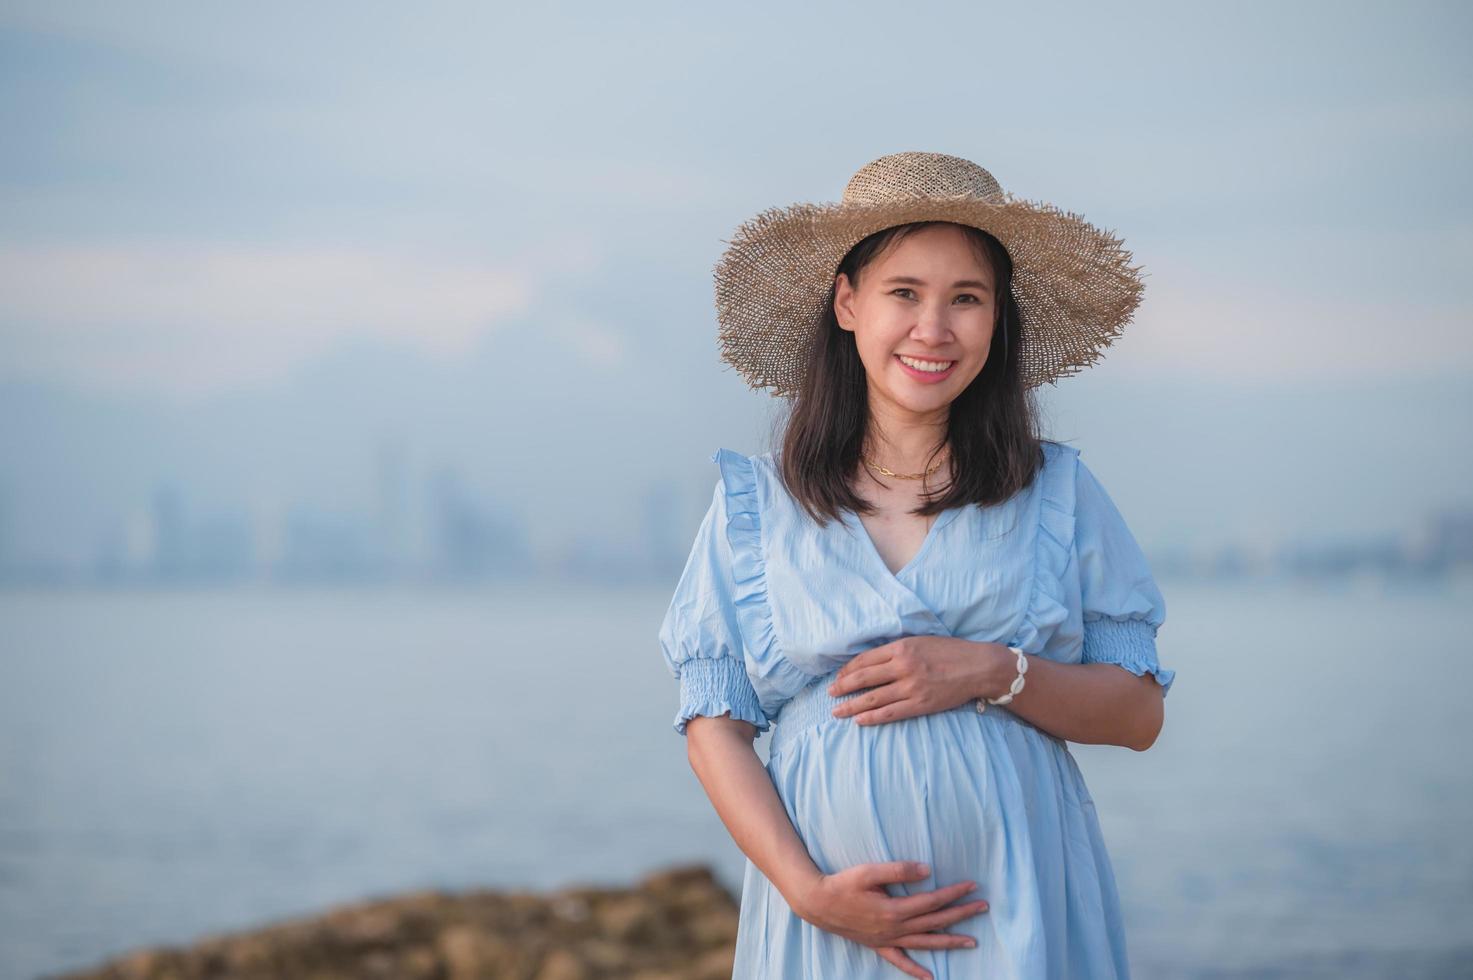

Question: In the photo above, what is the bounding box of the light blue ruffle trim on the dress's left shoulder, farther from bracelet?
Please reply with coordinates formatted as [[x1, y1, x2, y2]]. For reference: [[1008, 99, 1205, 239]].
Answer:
[[711, 449, 812, 696]]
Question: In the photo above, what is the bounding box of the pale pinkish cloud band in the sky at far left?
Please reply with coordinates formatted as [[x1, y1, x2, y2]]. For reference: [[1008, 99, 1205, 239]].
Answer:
[[0, 242, 542, 393]]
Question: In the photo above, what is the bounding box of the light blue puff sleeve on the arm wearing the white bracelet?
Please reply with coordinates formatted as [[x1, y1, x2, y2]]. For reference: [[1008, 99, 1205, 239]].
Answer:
[[1072, 460, 1175, 697]]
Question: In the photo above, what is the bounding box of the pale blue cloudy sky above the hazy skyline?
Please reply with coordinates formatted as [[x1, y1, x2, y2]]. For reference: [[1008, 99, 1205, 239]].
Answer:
[[0, 0, 1473, 560]]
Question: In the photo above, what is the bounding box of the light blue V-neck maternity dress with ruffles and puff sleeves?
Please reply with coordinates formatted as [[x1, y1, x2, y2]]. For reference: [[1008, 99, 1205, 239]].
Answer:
[[660, 442, 1174, 980]]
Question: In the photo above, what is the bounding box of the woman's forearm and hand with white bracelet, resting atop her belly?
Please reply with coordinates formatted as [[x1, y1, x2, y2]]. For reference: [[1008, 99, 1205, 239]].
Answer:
[[829, 637, 1165, 752]]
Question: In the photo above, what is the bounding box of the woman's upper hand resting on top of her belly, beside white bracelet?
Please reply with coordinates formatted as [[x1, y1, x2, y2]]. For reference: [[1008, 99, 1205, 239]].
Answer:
[[828, 637, 1015, 725]]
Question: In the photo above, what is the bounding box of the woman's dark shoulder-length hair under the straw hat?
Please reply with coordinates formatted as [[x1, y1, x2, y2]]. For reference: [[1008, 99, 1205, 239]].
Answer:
[[776, 221, 1043, 525]]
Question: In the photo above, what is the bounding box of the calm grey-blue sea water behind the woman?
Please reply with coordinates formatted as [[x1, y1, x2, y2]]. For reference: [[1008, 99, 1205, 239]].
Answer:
[[0, 581, 1473, 979]]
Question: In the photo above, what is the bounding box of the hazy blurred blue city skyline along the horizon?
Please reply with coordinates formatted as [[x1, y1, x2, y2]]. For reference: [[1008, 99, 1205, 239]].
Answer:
[[0, 392, 1473, 587]]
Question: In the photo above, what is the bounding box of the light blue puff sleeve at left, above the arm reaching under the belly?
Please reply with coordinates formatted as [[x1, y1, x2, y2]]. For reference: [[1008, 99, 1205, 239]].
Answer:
[[660, 480, 770, 735]]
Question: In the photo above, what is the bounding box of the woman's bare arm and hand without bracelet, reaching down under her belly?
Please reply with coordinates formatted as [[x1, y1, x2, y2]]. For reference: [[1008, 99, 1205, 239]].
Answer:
[[685, 715, 987, 980]]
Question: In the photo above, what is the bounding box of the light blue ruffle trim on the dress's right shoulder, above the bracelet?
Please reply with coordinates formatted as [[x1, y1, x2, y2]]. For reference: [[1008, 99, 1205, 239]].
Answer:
[[1012, 442, 1080, 653]]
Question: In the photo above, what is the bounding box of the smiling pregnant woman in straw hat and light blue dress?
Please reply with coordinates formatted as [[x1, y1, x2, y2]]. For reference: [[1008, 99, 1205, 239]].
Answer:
[[660, 153, 1173, 980]]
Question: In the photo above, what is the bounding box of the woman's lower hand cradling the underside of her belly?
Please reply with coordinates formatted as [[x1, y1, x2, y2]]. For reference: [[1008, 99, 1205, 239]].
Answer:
[[790, 861, 987, 980]]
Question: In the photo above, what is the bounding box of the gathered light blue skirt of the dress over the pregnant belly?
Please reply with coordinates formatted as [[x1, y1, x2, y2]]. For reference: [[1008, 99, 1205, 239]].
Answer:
[[732, 671, 1130, 980]]
